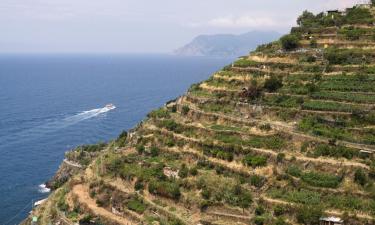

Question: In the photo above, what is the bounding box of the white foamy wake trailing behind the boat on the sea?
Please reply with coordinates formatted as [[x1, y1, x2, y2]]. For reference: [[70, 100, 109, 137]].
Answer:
[[0, 107, 114, 146]]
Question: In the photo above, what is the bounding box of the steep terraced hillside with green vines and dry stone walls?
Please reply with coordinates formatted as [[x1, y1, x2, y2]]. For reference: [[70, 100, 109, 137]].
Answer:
[[26, 5, 375, 225]]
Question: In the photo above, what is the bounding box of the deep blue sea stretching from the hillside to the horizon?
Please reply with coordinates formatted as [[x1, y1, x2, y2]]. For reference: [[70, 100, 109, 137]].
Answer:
[[0, 55, 232, 225]]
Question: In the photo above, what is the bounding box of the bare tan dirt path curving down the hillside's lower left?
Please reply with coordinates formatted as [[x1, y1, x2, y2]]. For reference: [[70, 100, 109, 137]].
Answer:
[[72, 184, 136, 225]]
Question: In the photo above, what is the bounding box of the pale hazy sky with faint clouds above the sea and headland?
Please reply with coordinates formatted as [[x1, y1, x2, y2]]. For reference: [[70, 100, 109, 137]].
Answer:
[[0, 0, 364, 53]]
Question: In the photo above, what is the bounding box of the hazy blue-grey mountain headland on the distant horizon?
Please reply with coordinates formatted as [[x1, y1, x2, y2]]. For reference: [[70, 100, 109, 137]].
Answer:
[[174, 31, 281, 56]]
